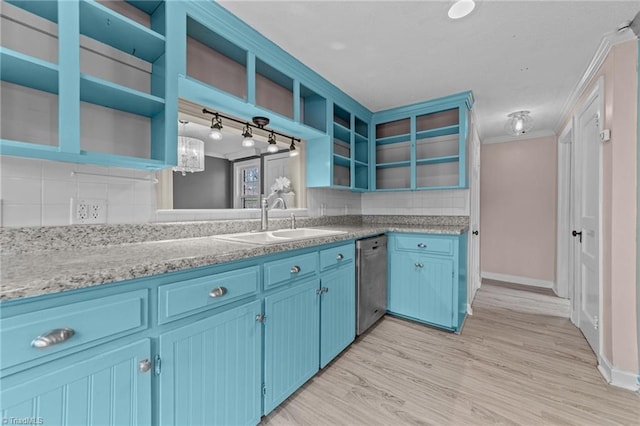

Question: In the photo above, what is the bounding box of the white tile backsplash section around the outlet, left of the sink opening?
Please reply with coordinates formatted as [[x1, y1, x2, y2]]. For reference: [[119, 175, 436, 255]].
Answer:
[[0, 156, 156, 227]]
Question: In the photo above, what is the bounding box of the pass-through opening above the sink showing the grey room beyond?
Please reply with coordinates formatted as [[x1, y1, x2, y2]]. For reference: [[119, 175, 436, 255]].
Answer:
[[158, 100, 306, 210]]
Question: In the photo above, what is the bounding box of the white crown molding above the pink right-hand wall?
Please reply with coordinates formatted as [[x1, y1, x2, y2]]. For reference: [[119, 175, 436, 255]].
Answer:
[[554, 30, 638, 134]]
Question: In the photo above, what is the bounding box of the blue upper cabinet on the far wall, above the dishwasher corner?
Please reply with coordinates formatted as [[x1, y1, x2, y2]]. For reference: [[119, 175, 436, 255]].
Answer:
[[371, 92, 473, 191]]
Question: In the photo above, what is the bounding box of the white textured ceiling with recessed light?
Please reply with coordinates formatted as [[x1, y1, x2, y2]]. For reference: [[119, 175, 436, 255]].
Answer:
[[219, 0, 640, 140]]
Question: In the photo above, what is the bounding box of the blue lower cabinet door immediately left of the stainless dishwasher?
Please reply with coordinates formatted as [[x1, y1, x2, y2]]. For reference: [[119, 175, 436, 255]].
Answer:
[[320, 263, 356, 368]]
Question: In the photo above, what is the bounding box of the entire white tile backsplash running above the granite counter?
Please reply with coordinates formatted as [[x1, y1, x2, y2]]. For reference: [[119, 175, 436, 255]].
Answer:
[[0, 156, 469, 227]]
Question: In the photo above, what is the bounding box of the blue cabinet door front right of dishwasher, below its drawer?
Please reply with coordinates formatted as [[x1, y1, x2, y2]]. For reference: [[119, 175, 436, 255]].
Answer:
[[388, 252, 456, 328]]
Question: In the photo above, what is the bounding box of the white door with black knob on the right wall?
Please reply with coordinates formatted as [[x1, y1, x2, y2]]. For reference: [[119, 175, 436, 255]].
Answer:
[[575, 81, 602, 355]]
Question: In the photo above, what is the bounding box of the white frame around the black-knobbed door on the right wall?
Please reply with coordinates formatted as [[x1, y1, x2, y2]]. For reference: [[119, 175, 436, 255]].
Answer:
[[571, 76, 605, 356]]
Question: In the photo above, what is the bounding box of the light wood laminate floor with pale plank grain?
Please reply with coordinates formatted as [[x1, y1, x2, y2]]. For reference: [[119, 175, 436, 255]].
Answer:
[[262, 285, 640, 426]]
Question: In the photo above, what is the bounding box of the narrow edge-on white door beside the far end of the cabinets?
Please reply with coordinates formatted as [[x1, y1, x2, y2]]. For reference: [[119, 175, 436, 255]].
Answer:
[[468, 116, 480, 306]]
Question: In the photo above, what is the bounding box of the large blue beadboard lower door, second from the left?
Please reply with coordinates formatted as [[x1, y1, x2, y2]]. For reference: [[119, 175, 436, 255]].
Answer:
[[159, 301, 262, 426]]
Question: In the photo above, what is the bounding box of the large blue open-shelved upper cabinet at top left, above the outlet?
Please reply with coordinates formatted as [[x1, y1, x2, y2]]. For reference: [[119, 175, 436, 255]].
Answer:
[[0, 0, 177, 170]]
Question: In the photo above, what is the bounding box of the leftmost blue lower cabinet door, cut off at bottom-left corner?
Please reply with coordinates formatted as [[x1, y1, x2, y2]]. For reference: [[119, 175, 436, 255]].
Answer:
[[0, 339, 152, 426]]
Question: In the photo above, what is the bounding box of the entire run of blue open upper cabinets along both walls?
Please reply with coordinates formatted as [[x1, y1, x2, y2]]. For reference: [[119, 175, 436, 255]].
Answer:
[[0, 0, 473, 181]]
